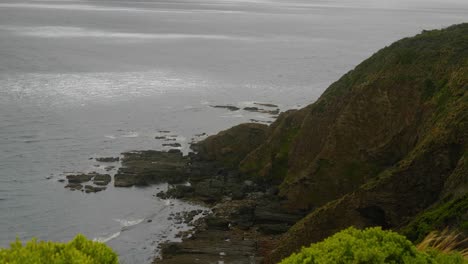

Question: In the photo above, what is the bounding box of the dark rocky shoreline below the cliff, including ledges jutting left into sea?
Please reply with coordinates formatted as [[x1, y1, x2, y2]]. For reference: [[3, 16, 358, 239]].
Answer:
[[59, 123, 294, 263]]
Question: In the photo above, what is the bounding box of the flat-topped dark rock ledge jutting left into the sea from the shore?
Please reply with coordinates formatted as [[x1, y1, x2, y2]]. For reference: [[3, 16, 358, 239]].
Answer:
[[114, 150, 188, 187]]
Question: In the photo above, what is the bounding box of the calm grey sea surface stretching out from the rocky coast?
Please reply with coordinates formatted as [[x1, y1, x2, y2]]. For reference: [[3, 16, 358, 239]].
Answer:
[[0, 0, 468, 263]]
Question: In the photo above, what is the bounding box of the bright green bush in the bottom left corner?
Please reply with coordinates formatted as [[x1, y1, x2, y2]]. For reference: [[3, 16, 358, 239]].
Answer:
[[0, 235, 118, 264]]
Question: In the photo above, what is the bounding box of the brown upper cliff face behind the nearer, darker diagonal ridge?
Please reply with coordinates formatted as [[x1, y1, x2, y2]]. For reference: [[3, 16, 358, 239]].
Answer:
[[241, 24, 468, 208]]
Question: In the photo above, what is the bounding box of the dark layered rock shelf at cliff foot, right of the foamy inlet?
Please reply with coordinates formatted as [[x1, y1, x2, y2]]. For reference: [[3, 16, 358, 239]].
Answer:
[[153, 155, 304, 264]]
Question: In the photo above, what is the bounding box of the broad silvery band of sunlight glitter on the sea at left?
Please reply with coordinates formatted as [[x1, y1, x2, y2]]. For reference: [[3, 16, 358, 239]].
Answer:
[[0, 71, 208, 106]]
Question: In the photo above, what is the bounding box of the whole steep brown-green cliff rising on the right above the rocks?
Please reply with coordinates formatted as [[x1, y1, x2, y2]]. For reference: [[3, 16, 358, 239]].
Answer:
[[193, 24, 468, 263]]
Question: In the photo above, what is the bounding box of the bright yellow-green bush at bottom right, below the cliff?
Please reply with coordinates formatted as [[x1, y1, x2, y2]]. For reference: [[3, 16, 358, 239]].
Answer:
[[281, 227, 468, 264]]
